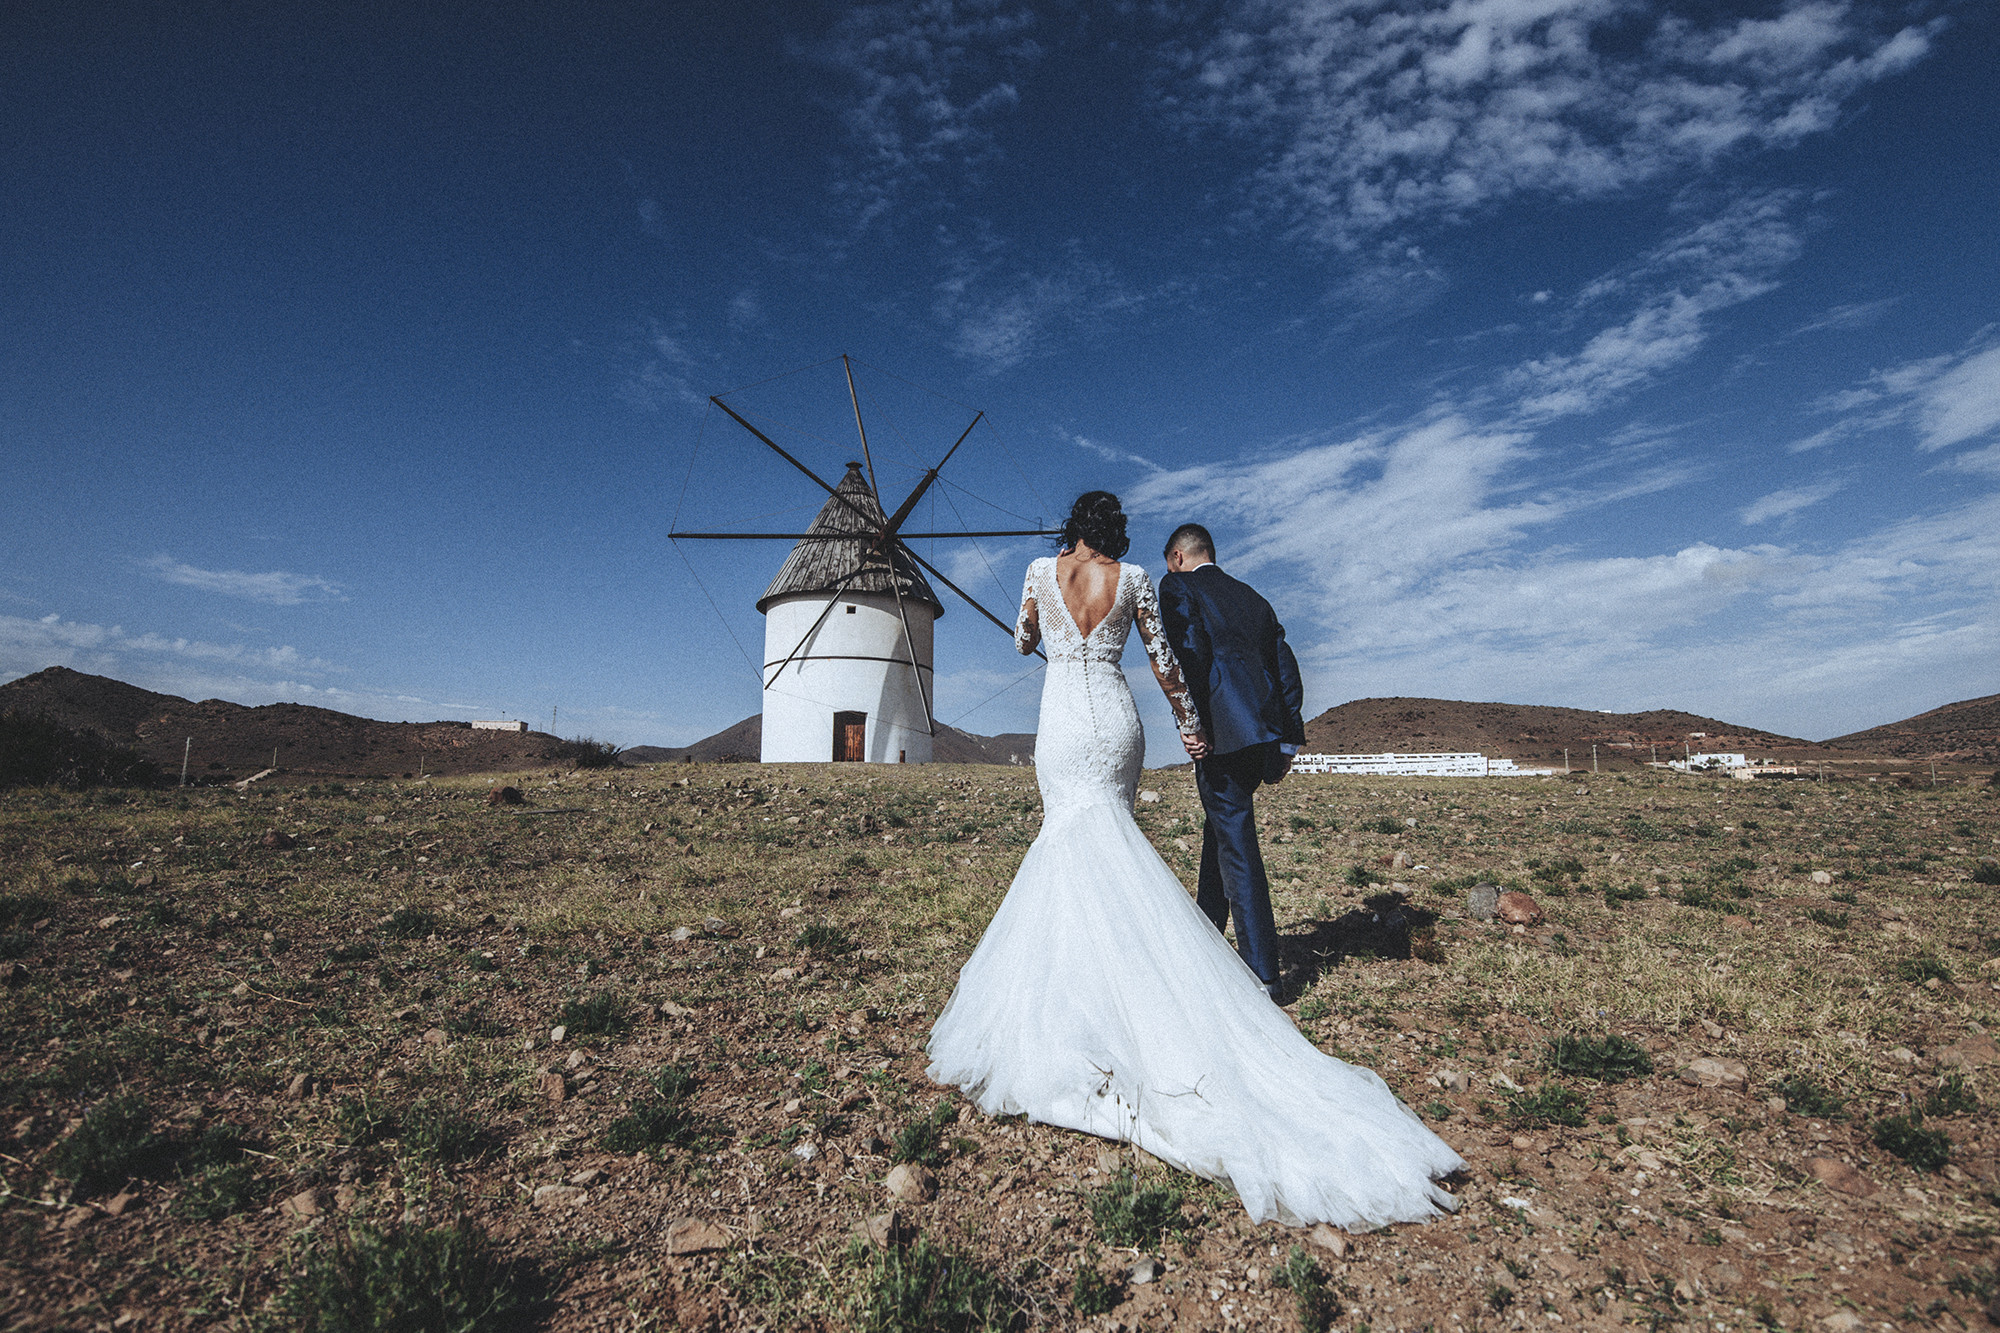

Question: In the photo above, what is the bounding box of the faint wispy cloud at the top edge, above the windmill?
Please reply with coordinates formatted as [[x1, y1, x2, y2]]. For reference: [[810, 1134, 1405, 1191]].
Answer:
[[812, 0, 1042, 230]]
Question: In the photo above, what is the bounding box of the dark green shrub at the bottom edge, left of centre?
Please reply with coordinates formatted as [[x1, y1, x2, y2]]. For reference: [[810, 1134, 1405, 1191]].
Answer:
[[278, 1221, 524, 1333]]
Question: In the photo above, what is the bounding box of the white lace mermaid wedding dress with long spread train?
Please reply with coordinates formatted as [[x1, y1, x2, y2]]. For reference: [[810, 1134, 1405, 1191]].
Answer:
[[928, 558, 1464, 1229]]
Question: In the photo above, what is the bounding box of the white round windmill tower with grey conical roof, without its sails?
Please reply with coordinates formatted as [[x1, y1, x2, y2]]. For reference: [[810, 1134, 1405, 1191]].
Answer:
[[756, 462, 944, 765]]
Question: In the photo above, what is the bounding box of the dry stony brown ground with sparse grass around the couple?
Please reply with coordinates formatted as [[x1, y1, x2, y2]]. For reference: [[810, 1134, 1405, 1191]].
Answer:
[[0, 765, 2000, 1333]]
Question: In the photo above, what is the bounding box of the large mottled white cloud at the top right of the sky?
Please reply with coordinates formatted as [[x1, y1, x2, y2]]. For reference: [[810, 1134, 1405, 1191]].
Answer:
[[1156, 0, 1942, 248]]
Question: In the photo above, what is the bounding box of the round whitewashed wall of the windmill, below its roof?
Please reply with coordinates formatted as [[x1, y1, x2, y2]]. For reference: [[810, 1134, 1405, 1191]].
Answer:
[[762, 592, 936, 765]]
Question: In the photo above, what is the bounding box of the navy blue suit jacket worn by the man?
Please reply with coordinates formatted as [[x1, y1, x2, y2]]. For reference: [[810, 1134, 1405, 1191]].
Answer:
[[1160, 564, 1306, 755]]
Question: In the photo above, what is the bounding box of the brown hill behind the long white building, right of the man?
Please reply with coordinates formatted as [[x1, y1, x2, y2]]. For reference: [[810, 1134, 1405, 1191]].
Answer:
[[1306, 699, 1820, 769]]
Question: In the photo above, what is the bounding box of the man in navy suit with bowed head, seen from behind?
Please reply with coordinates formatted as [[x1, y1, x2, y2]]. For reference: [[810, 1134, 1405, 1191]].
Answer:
[[1160, 522, 1306, 1003]]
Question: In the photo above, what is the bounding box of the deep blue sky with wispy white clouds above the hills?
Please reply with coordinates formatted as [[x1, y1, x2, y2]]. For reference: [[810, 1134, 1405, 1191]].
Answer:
[[0, 0, 2000, 761]]
